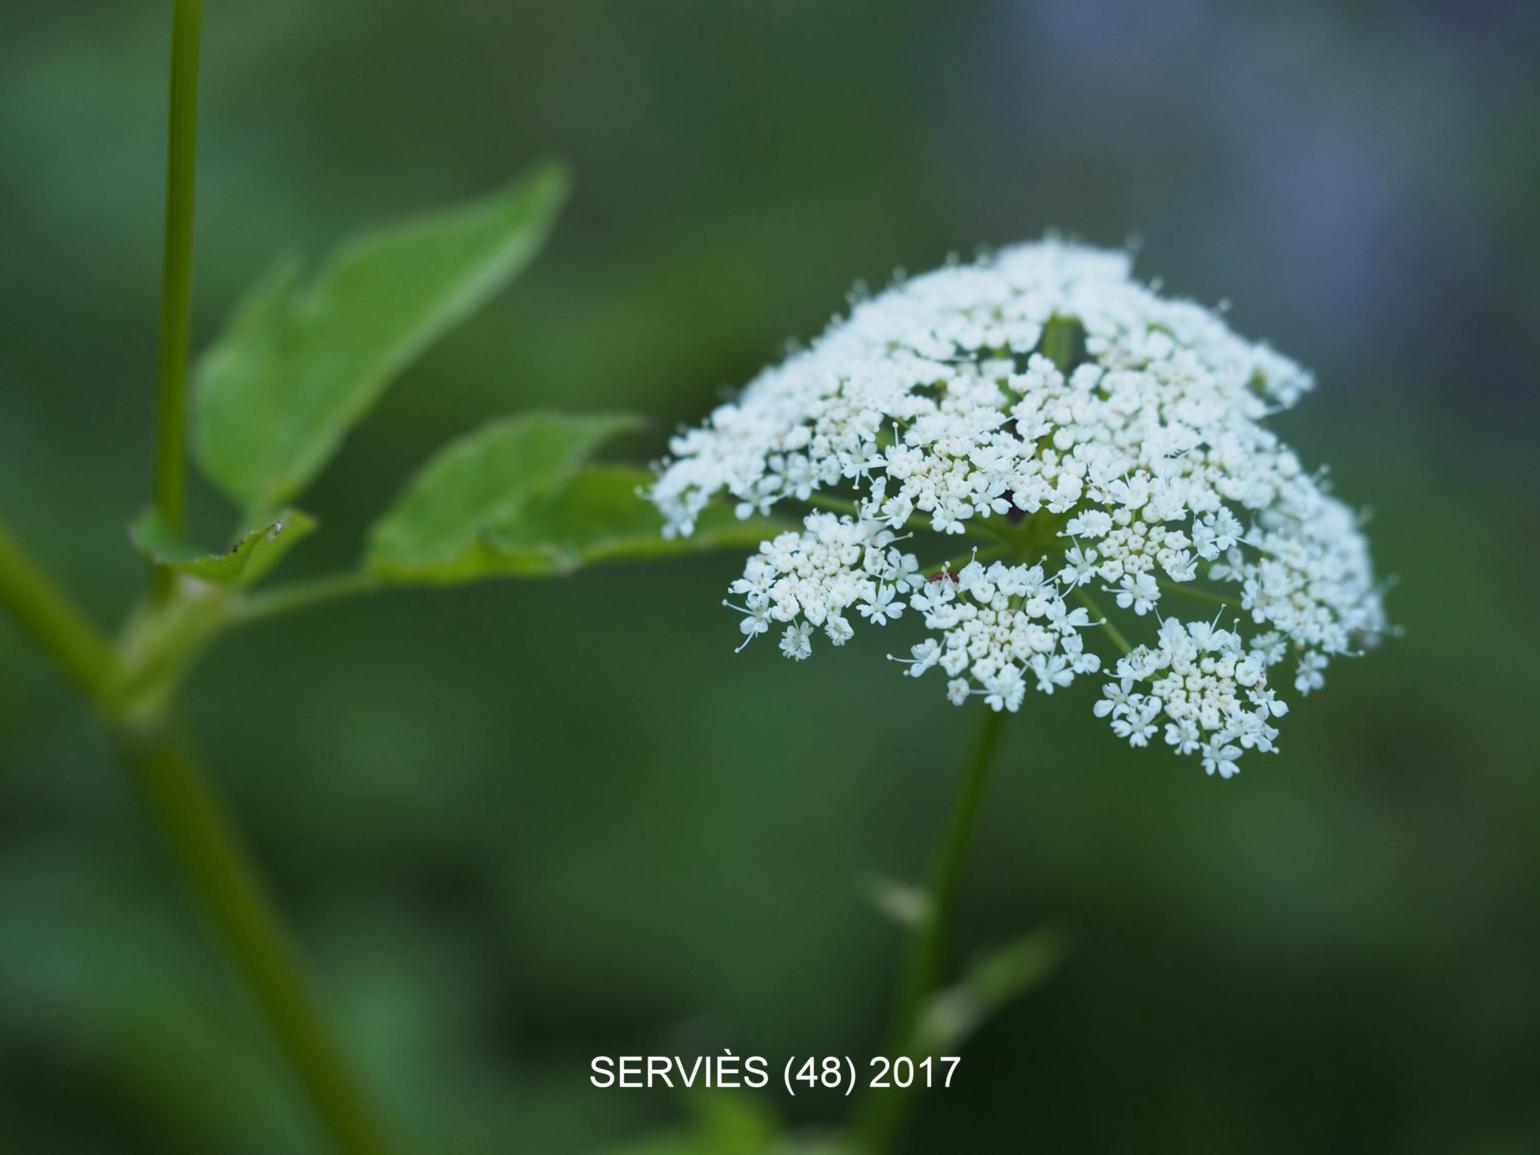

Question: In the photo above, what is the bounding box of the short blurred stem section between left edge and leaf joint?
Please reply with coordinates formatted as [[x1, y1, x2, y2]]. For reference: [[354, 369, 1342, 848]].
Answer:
[[0, 521, 117, 708]]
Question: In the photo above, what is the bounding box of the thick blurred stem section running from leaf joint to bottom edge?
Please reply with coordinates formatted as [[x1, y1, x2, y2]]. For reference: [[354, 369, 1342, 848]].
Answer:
[[122, 736, 393, 1155]]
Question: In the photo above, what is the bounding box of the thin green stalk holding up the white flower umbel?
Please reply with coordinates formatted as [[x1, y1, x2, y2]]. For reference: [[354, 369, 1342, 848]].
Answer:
[[856, 710, 1006, 1155]]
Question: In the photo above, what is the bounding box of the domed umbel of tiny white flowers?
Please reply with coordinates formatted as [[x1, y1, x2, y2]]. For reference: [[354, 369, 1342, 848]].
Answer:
[[648, 240, 1384, 778]]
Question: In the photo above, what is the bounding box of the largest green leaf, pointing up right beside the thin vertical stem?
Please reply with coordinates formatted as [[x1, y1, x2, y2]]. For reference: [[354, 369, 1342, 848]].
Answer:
[[196, 165, 567, 514]]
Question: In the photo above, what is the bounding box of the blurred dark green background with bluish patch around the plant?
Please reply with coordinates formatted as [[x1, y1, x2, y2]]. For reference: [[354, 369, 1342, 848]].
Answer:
[[0, 0, 1540, 1155]]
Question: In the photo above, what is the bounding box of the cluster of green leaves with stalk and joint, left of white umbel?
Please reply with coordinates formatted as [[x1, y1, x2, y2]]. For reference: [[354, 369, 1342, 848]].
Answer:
[[130, 165, 773, 715]]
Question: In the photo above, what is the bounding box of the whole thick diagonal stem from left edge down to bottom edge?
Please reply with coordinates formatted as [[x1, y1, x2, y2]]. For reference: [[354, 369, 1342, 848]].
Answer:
[[0, 522, 403, 1155]]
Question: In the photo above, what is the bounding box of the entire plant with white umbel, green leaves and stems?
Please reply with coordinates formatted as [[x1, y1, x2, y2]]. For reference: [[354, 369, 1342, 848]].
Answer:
[[0, 9, 1384, 1155]]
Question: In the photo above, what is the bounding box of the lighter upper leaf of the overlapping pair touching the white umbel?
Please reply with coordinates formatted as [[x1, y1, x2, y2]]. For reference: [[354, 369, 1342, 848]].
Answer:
[[367, 413, 639, 582]]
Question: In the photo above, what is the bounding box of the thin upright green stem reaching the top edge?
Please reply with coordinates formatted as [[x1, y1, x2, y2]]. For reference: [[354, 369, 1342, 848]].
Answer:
[[154, 0, 203, 533]]
